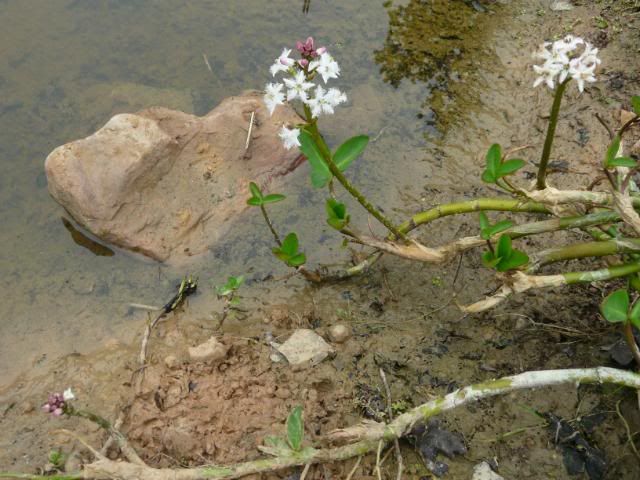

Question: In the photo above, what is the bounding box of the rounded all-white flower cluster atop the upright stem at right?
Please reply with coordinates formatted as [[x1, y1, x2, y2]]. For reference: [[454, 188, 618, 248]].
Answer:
[[533, 35, 600, 93]]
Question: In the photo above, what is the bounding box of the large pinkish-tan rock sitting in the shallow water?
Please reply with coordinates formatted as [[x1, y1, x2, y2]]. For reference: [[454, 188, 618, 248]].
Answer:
[[45, 92, 301, 261]]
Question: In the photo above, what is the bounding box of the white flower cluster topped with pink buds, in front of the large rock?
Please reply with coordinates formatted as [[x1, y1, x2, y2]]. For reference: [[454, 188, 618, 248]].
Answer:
[[264, 37, 347, 149]]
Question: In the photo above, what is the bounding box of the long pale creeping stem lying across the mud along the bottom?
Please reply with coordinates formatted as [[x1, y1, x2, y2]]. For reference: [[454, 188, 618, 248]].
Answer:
[[0, 367, 640, 480]]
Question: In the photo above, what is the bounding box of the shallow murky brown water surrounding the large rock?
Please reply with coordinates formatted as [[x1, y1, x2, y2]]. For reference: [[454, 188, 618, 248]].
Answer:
[[0, 0, 500, 386]]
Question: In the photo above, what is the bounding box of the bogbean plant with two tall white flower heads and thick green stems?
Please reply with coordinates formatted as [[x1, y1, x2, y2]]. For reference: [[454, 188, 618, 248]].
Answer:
[[248, 35, 640, 364]]
